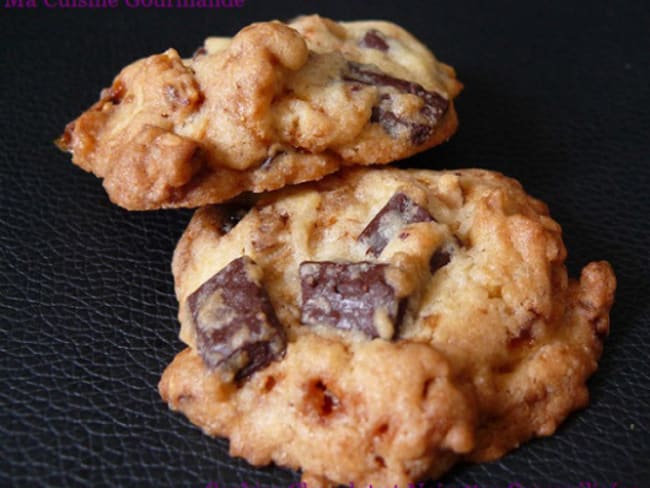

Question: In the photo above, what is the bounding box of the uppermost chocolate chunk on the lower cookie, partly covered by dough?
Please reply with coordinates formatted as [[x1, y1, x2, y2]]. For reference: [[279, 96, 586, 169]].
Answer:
[[358, 193, 435, 256]]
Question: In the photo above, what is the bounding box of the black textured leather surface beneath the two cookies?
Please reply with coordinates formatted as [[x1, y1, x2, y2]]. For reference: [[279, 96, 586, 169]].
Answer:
[[0, 0, 650, 488]]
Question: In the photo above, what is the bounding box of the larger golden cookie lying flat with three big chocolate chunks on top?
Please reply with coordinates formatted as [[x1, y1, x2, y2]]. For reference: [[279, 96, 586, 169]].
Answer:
[[159, 168, 616, 486]]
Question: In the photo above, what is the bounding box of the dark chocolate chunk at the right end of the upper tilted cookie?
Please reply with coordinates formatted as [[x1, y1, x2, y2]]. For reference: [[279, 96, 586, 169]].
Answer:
[[343, 63, 449, 146]]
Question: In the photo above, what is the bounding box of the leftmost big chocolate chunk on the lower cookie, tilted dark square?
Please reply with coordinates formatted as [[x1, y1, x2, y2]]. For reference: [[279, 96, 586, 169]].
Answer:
[[187, 256, 286, 381]]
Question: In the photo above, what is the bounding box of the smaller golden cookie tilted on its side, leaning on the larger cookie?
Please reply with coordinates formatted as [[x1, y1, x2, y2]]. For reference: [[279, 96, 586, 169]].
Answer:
[[58, 16, 461, 210]]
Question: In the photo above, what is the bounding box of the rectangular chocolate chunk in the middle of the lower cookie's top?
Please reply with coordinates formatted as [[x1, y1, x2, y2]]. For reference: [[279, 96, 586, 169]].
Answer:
[[300, 261, 400, 339]]
